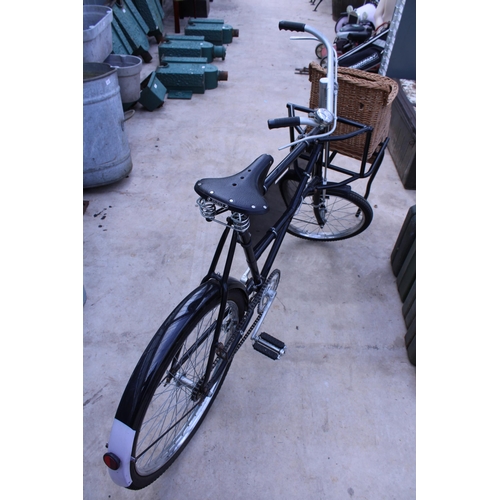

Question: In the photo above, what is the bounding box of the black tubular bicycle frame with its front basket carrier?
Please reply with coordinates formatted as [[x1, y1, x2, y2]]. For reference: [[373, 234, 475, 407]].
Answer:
[[196, 103, 388, 394]]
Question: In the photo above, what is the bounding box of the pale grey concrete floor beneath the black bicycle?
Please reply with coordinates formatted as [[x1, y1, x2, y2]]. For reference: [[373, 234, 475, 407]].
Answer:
[[83, 0, 416, 500]]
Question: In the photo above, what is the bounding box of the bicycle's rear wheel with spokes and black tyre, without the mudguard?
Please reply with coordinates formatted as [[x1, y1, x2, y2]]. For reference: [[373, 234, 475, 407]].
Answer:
[[125, 289, 245, 490]]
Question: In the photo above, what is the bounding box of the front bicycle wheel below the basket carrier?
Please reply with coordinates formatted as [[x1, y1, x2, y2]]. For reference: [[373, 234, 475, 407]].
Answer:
[[279, 172, 373, 241]]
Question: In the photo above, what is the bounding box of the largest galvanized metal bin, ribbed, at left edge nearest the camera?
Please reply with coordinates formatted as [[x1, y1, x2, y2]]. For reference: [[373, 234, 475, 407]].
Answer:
[[83, 63, 132, 188]]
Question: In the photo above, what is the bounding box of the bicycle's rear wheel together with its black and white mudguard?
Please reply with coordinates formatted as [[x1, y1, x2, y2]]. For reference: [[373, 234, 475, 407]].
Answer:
[[105, 280, 248, 490]]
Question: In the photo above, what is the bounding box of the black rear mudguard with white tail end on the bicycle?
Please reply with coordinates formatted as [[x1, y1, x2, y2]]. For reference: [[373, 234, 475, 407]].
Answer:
[[108, 278, 248, 487]]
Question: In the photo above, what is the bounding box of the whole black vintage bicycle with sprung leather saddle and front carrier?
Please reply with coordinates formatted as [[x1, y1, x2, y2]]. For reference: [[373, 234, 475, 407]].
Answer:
[[104, 21, 388, 489]]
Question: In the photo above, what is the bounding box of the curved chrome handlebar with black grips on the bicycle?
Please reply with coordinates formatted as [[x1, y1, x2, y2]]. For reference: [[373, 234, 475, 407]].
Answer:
[[268, 21, 338, 149]]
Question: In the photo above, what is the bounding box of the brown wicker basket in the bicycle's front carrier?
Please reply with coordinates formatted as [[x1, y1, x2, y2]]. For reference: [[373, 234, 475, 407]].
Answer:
[[309, 61, 398, 160]]
